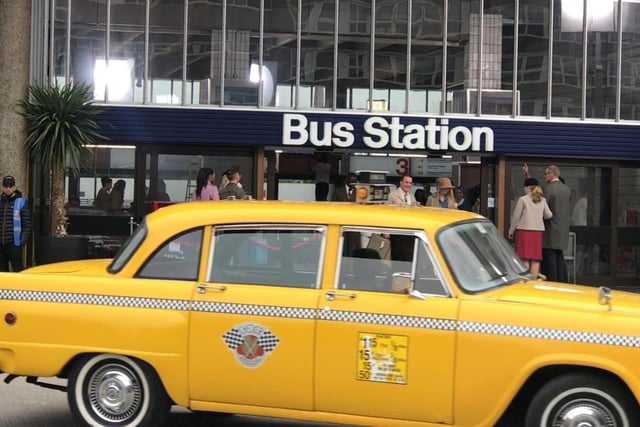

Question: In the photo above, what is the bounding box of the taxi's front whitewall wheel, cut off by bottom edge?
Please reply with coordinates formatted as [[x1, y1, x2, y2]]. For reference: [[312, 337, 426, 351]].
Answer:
[[526, 373, 640, 427]]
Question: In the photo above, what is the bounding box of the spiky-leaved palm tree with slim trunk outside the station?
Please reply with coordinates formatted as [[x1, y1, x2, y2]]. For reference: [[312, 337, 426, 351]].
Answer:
[[20, 82, 103, 236]]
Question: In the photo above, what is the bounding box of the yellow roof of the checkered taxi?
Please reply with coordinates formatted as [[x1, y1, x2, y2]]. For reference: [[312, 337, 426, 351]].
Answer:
[[146, 200, 483, 232]]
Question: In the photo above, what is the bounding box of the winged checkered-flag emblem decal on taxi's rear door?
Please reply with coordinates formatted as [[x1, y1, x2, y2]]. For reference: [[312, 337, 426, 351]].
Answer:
[[222, 322, 280, 368]]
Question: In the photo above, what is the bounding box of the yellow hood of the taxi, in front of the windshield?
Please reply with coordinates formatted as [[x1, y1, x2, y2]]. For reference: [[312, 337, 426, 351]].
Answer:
[[494, 281, 640, 316]]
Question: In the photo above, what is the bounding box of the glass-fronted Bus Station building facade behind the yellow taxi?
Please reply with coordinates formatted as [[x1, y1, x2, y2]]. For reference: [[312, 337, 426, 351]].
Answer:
[[12, 0, 640, 287]]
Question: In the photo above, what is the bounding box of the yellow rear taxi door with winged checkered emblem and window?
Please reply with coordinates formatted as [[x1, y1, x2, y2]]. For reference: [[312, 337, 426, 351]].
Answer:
[[189, 224, 326, 410]]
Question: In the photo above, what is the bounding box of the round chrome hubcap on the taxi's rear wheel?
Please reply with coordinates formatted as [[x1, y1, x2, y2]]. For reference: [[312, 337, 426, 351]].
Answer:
[[87, 365, 141, 422]]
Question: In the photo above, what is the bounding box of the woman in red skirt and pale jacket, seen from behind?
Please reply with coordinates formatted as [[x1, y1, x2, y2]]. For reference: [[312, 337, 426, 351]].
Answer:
[[509, 178, 553, 277]]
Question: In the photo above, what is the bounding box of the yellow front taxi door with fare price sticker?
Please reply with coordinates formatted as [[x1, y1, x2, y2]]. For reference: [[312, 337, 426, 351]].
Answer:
[[315, 227, 458, 424]]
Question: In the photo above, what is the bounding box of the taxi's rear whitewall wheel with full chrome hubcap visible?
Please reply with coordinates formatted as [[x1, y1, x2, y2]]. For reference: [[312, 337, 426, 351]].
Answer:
[[67, 354, 171, 427]]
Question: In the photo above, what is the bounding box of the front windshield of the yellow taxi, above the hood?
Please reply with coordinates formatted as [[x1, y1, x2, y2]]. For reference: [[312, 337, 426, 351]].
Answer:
[[437, 220, 534, 293]]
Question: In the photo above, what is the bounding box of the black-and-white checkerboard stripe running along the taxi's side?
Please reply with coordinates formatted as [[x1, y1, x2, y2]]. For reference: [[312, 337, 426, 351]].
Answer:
[[0, 289, 640, 348]]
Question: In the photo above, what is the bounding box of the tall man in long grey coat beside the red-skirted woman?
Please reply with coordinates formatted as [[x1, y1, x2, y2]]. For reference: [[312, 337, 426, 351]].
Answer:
[[522, 163, 571, 282]]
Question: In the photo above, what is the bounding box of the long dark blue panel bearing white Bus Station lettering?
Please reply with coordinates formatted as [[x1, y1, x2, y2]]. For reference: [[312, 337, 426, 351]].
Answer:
[[101, 106, 640, 159]]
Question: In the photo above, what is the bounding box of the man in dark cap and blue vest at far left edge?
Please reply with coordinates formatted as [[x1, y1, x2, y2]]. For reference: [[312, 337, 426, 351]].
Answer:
[[0, 175, 31, 272]]
